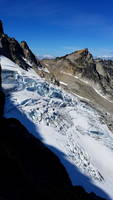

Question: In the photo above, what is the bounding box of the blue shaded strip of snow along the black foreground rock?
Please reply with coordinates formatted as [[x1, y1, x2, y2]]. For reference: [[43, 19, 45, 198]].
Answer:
[[4, 96, 111, 200]]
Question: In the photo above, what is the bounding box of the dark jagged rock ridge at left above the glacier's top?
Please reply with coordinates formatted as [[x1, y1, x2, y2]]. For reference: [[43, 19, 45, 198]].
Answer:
[[0, 21, 40, 70]]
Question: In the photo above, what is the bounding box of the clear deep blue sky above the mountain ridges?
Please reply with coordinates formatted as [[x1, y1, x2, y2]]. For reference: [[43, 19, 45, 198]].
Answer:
[[0, 0, 113, 56]]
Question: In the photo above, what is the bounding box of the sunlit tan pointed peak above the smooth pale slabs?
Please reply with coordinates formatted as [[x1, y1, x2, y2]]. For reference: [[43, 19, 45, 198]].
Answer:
[[42, 49, 100, 81]]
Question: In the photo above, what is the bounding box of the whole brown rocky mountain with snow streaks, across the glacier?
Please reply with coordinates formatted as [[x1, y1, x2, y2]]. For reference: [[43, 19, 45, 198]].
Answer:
[[40, 49, 113, 106]]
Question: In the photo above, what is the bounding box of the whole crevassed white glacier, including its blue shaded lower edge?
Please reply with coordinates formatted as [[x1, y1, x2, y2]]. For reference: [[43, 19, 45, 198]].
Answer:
[[0, 56, 113, 199]]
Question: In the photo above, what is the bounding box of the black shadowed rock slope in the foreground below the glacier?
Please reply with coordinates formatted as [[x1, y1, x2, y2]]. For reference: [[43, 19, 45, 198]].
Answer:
[[0, 118, 106, 200]]
